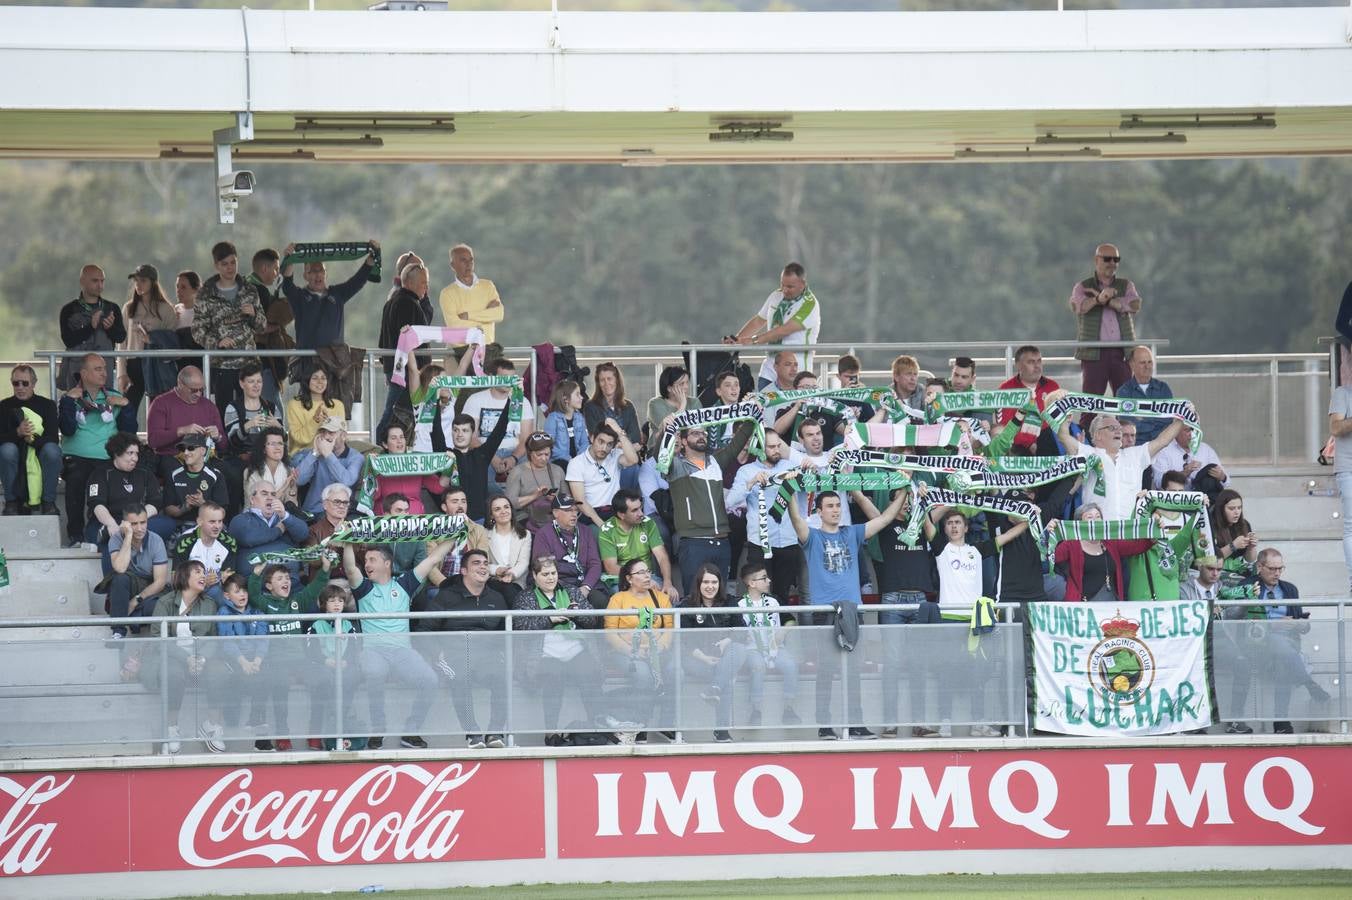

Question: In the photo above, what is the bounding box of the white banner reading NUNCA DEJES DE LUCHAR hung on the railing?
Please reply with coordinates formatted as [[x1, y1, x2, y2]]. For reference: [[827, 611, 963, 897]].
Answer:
[[1023, 600, 1215, 736]]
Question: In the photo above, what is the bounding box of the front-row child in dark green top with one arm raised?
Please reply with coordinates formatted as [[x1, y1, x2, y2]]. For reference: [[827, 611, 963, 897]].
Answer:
[[249, 562, 329, 753]]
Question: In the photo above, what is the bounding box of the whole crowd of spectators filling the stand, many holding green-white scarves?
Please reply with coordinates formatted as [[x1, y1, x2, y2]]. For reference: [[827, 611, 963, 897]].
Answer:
[[0, 241, 1322, 751]]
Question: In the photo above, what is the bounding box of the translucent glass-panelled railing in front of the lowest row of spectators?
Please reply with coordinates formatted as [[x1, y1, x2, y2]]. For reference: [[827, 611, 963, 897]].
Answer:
[[0, 599, 1352, 755]]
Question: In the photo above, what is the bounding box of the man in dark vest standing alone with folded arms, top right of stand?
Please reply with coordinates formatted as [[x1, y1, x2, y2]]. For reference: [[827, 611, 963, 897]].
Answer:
[[1071, 243, 1141, 405]]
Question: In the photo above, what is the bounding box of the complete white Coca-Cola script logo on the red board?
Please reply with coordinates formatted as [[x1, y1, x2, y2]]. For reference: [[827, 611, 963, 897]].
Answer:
[[178, 762, 479, 869]]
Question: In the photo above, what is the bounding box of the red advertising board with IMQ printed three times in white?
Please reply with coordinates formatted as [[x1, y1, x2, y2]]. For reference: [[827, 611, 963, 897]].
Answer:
[[558, 747, 1352, 858]]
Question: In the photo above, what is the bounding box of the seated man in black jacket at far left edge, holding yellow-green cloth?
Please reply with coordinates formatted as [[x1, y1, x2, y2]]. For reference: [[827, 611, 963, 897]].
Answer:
[[0, 365, 61, 516]]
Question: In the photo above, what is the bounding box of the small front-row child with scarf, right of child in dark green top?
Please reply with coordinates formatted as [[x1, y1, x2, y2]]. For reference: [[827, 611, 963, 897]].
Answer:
[[306, 584, 366, 750]]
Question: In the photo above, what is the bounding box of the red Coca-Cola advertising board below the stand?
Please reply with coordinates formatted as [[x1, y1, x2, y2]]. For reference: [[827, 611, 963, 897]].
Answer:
[[0, 759, 545, 876]]
